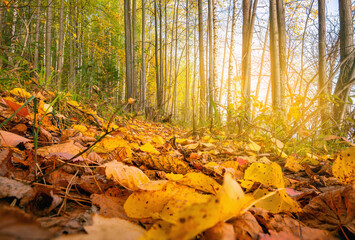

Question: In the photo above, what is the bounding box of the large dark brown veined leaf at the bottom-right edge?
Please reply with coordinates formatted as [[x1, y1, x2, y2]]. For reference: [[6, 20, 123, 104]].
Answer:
[[301, 184, 355, 234]]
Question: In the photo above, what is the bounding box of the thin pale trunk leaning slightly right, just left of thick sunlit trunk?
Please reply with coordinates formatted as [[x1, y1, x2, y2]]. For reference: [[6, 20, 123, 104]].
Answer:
[[227, 0, 237, 130]]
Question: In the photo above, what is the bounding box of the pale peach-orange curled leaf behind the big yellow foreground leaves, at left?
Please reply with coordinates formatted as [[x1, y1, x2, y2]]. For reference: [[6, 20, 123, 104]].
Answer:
[[105, 161, 150, 191]]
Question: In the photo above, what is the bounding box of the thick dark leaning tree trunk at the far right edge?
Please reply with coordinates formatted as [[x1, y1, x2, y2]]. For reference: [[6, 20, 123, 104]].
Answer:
[[333, 0, 355, 124]]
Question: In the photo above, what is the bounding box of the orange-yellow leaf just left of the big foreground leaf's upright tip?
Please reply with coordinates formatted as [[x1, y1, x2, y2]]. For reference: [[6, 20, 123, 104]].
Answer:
[[178, 172, 221, 194]]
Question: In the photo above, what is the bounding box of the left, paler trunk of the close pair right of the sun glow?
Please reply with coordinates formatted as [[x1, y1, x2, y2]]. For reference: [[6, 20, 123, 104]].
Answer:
[[270, 0, 281, 111]]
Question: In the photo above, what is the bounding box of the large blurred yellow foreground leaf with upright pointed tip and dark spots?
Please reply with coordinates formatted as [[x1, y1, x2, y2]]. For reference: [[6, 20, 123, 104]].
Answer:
[[142, 174, 252, 240]]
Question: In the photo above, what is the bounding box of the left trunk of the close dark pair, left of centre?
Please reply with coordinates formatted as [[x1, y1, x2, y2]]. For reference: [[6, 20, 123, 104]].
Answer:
[[124, 0, 132, 101]]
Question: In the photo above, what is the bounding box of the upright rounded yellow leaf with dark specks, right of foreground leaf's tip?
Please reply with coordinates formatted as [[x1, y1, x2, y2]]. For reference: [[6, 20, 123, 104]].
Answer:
[[244, 162, 285, 188]]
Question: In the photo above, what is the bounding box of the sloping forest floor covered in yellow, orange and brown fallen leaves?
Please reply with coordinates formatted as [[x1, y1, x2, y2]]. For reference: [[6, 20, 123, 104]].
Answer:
[[0, 88, 355, 240]]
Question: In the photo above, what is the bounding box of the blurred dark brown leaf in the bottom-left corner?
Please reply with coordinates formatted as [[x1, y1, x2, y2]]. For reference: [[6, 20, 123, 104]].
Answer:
[[0, 207, 51, 240]]
